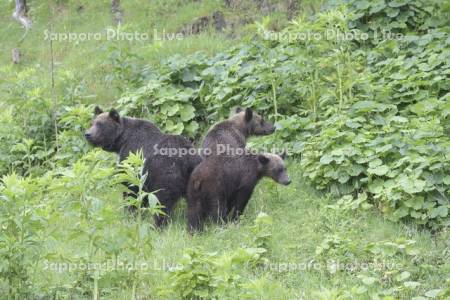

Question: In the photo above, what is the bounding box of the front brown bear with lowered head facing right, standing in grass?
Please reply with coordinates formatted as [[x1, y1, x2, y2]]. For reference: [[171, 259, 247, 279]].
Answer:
[[187, 153, 291, 232]]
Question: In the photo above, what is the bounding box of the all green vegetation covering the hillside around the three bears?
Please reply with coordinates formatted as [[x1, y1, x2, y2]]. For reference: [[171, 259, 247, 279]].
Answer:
[[0, 0, 450, 300]]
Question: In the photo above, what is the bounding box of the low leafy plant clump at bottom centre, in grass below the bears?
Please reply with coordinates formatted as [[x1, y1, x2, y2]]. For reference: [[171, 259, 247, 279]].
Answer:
[[166, 213, 276, 299]]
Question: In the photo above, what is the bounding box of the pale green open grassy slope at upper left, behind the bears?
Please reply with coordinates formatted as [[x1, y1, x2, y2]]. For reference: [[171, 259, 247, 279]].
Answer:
[[0, 0, 232, 103]]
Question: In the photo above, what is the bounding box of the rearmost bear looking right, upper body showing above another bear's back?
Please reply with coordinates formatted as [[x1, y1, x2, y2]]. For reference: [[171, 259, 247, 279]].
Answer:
[[202, 108, 275, 157]]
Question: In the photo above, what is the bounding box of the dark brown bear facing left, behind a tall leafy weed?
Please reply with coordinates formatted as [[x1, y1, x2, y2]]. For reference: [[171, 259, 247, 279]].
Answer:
[[85, 107, 201, 227]]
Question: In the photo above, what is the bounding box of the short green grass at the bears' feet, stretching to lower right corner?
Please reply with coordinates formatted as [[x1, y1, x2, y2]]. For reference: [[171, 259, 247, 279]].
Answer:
[[154, 161, 450, 299]]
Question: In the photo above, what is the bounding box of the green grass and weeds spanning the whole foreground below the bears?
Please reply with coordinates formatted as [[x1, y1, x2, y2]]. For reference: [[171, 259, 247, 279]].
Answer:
[[1, 159, 449, 299]]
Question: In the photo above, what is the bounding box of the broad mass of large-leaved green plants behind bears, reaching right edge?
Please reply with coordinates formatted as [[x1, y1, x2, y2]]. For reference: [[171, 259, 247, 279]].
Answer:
[[110, 0, 450, 226]]
